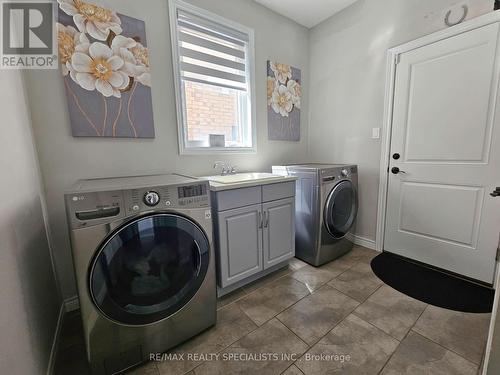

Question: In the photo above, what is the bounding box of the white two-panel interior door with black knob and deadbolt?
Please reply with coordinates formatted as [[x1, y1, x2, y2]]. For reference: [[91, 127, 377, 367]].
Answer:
[[384, 23, 500, 284]]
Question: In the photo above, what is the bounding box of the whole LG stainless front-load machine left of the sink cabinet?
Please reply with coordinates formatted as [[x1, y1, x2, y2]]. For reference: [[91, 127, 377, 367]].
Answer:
[[65, 175, 216, 374]]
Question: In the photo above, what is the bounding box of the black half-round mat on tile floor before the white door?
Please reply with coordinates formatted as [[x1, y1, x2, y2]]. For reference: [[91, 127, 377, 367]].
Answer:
[[371, 252, 495, 313]]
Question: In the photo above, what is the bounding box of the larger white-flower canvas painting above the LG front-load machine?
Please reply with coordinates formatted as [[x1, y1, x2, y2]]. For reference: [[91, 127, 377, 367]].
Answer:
[[57, 0, 155, 138]]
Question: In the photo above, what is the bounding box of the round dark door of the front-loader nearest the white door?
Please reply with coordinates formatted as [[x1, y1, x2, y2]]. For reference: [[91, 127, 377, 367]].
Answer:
[[324, 180, 358, 238]]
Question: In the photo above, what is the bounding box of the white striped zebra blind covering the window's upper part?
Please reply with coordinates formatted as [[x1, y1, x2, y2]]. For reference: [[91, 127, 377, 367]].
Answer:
[[177, 9, 249, 91]]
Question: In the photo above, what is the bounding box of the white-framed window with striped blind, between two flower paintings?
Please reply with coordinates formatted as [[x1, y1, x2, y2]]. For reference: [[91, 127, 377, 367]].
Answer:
[[170, 0, 255, 154]]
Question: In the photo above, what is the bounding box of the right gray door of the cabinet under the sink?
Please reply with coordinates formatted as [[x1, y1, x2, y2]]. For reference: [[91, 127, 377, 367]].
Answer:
[[262, 198, 295, 269]]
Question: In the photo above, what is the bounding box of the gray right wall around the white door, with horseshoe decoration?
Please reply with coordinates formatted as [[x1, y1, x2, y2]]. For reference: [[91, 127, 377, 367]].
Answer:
[[309, 0, 493, 240]]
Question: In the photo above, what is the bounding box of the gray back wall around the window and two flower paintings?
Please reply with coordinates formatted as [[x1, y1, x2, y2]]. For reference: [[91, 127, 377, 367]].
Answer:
[[27, 0, 309, 298]]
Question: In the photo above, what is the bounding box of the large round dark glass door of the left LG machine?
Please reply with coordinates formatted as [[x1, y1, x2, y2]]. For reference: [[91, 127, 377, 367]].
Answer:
[[89, 214, 210, 325]]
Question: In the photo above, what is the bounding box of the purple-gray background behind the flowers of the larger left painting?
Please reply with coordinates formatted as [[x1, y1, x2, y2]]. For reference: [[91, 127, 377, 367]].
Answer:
[[58, 9, 155, 138]]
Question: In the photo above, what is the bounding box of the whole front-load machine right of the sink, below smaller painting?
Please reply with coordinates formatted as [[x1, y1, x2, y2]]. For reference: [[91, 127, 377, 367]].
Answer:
[[273, 163, 358, 266]]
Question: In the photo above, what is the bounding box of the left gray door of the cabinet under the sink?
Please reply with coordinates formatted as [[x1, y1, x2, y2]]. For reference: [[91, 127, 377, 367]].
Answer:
[[218, 204, 263, 288]]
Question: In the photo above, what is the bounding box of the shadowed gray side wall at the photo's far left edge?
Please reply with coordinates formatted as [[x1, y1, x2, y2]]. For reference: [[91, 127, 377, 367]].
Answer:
[[0, 71, 60, 375]]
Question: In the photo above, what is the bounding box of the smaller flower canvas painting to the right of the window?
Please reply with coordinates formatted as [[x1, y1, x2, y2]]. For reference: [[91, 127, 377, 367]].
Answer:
[[267, 61, 302, 141]]
